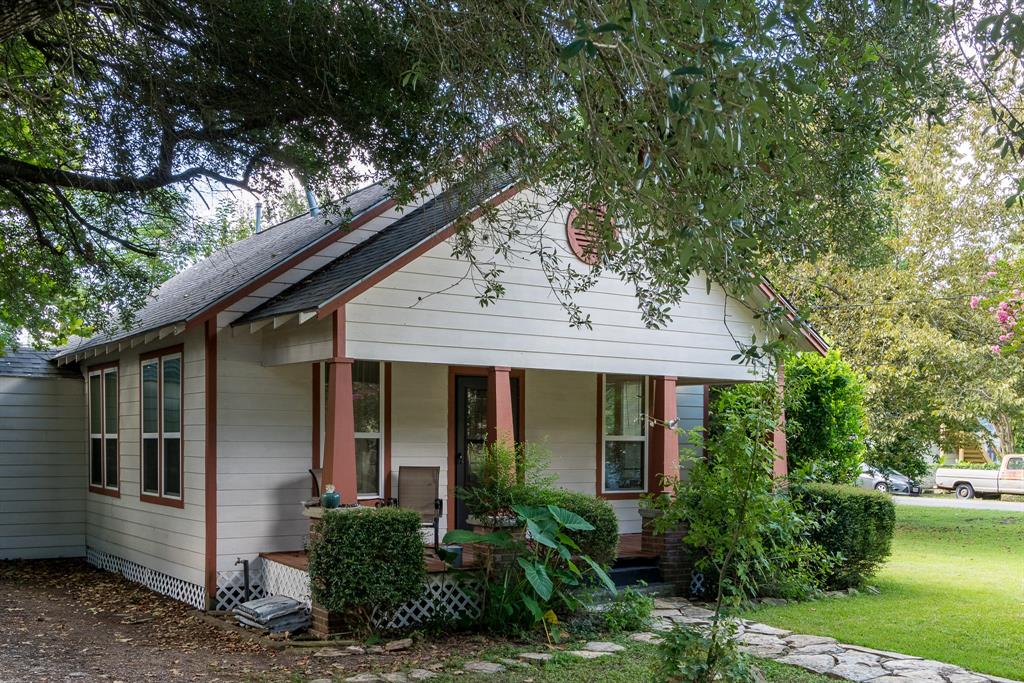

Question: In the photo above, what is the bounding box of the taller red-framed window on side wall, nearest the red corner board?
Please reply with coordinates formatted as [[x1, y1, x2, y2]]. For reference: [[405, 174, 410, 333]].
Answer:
[[141, 347, 184, 505]]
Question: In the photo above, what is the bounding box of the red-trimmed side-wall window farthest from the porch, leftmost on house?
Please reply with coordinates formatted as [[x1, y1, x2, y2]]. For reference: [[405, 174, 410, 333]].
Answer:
[[88, 366, 119, 496]]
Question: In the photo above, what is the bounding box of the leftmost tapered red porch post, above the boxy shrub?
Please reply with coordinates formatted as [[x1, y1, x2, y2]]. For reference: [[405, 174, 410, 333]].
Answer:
[[324, 308, 357, 504]]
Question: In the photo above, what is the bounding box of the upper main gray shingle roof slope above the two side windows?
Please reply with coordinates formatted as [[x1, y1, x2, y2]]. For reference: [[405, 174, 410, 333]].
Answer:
[[57, 182, 390, 356]]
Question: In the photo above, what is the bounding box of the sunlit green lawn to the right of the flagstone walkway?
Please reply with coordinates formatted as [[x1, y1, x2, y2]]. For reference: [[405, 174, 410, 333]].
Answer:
[[748, 506, 1024, 680]]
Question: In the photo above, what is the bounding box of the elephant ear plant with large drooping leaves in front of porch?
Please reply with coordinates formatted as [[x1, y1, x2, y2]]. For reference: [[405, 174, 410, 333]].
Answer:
[[444, 505, 615, 641]]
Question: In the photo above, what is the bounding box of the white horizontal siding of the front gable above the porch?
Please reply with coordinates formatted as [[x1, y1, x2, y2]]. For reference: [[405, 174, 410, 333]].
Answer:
[[346, 193, 770, 381]]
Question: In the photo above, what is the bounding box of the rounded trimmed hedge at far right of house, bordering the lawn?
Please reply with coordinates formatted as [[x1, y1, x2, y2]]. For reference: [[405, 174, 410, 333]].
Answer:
[[791, 483, 896, 590]]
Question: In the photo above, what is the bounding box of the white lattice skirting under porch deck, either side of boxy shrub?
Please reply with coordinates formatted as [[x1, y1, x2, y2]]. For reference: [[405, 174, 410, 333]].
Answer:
[[263, 559, 483, 629]]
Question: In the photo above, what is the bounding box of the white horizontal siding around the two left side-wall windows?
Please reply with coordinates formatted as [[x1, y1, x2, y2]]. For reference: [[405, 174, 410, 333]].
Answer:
[[81, 329, 206, 586]]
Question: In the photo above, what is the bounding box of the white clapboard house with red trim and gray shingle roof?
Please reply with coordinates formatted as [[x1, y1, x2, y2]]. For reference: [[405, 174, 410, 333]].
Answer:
[[0, 175, 825, 607]]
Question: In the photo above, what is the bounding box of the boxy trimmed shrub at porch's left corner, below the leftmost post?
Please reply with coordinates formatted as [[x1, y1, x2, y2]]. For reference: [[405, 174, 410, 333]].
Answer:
[[309, 507, 427, 632]]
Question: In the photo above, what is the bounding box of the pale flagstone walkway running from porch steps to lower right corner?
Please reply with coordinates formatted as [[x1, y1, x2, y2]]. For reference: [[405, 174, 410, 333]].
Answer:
[[632, 598, 1017, 683]]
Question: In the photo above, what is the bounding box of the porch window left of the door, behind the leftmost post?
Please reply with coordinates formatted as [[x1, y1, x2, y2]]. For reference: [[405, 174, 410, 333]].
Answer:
[[321, 360, 384, 499]]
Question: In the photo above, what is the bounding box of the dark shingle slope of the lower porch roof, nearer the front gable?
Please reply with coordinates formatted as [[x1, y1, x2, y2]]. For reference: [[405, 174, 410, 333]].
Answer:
[[236, 173, 515, 325]]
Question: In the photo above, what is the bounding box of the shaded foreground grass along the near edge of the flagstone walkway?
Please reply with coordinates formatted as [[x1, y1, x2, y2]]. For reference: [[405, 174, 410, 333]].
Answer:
[[430, 639, 835, 683]]
